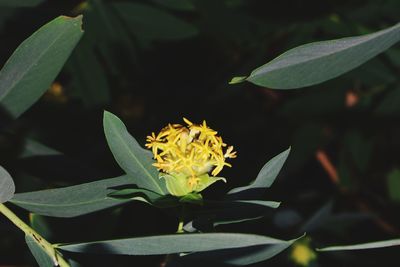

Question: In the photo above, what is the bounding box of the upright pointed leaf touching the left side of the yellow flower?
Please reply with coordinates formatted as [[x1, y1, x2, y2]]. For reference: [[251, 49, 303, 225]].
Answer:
[[104, 111, 168, 195]]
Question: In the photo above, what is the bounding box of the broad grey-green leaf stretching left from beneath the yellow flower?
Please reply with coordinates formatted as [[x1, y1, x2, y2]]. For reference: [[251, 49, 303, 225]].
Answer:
[[10, 175, 136, 218]]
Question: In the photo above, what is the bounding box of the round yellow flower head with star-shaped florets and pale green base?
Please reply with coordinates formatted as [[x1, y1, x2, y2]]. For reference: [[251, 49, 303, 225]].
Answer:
[[146, 118, 236, 196]]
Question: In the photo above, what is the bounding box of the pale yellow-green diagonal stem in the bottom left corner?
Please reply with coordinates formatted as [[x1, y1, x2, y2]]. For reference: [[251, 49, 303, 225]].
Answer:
[[0, 204, 70, 267]]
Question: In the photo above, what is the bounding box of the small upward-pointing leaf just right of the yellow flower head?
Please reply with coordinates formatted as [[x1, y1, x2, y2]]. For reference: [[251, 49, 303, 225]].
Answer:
[[228, 148, 290, 197]]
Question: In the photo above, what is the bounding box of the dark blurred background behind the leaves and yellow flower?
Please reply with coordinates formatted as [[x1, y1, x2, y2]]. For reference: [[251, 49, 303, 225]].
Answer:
[[0, 0, 400, 266]]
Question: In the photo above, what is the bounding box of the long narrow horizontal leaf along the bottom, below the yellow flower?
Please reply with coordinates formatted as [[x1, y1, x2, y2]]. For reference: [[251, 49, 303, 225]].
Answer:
[[59, 233, 296, 255]]
